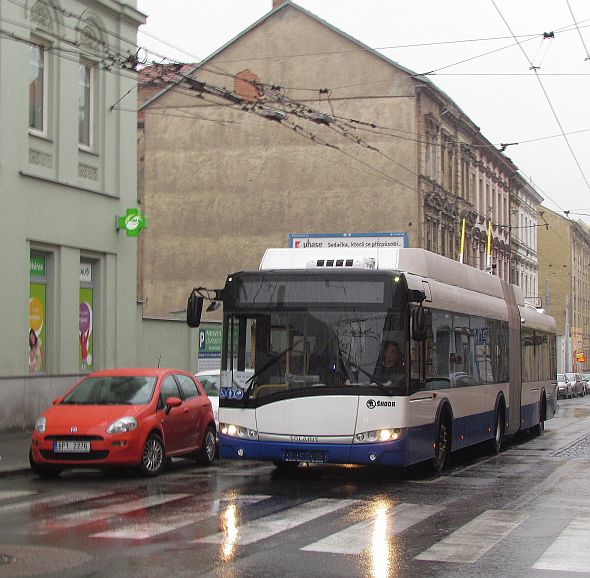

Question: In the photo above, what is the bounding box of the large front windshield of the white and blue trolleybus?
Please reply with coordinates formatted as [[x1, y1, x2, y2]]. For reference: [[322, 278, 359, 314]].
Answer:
[[225, 308, 407, 405]]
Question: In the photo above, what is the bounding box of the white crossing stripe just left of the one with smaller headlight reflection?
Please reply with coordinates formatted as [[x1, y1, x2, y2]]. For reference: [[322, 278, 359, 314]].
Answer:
[[90, 495, 271, 540]]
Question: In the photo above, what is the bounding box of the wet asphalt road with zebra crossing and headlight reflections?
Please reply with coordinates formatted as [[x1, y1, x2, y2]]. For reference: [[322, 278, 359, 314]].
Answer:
[[0, 396, 590, 578]]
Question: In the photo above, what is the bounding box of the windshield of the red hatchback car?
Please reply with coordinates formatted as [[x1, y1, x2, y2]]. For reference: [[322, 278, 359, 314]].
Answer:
[[61, 375, 156, 405]]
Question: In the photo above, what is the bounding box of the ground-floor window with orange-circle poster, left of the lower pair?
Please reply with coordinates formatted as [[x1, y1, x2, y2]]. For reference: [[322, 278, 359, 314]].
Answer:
[[28, 253, 47, 373]]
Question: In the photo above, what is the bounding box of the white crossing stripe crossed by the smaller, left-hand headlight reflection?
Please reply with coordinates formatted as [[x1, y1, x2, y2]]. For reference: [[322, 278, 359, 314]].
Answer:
[[195, 498, 359, 545]]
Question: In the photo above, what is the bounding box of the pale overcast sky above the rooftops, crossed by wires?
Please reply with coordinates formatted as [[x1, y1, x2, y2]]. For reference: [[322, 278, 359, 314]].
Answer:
[[137, 0, 590, 223]]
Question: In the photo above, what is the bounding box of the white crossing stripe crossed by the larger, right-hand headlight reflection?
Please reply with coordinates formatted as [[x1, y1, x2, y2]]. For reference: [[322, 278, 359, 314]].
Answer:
[[301, 503, 444, 554]]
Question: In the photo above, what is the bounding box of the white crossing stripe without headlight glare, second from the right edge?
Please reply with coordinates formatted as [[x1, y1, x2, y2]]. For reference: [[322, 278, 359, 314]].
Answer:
[[414, 510, 529, 564]]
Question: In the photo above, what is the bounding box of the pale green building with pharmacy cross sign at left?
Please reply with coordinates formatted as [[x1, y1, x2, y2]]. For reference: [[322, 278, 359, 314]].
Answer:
[[0, 0, 145, 429]]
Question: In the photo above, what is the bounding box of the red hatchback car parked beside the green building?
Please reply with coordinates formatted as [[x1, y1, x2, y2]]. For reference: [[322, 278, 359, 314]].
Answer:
[[29, 368, 216, 477]]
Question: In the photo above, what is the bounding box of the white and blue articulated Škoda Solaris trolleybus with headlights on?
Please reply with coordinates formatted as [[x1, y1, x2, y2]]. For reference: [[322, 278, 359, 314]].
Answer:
[[187, 249, 557, 471]]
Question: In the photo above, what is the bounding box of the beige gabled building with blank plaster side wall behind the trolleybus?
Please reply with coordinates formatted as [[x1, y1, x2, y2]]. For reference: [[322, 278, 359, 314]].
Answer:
[[139, 1, 536, 315]]
